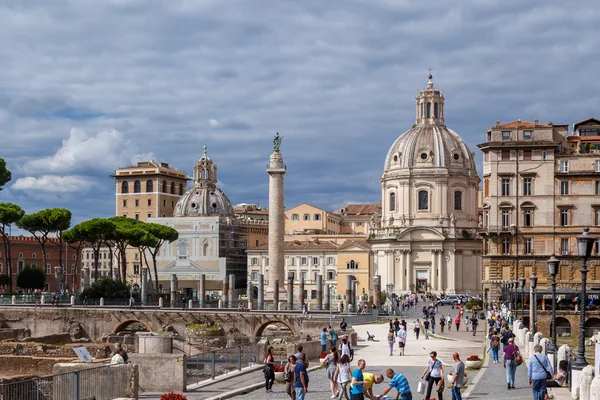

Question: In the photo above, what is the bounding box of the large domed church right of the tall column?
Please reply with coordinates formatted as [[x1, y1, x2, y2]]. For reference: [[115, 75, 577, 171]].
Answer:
[[369, 74, 482, 294]]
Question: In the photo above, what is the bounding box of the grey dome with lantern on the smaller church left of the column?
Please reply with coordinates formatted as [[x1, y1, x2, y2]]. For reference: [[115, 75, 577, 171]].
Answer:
[[173, 146, 234, 217]]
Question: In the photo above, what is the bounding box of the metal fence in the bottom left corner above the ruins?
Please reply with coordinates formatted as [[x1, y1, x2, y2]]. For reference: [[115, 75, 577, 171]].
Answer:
[[0, 364, 135, 400]]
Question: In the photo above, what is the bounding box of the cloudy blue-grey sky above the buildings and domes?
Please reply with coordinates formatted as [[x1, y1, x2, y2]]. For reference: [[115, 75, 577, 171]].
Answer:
[[0, 0, 600, 222]]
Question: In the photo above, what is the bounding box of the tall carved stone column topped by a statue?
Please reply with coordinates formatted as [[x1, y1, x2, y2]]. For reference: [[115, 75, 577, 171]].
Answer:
[[267, 133, 285, 300]]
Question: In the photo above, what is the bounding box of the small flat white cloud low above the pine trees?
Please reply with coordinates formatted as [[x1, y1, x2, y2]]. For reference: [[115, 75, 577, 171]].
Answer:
[[11, 175, 97, 195]]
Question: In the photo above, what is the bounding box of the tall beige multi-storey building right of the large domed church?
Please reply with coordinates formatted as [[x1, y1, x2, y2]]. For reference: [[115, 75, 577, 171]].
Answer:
[[478, 119, 600, 298]]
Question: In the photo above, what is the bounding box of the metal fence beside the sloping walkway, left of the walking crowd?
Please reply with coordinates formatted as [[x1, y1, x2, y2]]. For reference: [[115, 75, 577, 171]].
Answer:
[[186, 344, 259, 384]]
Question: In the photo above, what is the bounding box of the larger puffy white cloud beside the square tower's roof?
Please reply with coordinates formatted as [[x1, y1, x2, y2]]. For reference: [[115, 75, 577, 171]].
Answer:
[[22, 128, 154, 174]]
